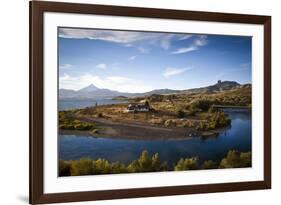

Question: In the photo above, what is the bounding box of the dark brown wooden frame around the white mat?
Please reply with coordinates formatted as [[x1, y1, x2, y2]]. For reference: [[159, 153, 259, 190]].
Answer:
[[29, 1, 271, 204]]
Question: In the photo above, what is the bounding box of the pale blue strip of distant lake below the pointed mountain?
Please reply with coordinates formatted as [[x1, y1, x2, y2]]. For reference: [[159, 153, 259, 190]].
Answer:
[[59, 99, 126, 110]]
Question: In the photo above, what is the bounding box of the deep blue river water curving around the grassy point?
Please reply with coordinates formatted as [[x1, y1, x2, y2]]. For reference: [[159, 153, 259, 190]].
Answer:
[[59, 110, 252, 165]]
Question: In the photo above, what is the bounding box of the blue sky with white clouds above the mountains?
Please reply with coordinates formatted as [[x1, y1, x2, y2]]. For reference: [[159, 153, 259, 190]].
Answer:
[[58, 28, 252, 93]]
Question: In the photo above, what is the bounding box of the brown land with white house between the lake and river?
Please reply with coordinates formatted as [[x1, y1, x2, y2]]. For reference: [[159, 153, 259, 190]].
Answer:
[[59, 81, 251, 140]]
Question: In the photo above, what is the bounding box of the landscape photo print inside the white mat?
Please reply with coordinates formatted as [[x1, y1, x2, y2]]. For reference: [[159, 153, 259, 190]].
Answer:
[[58, 27, 252, 177]]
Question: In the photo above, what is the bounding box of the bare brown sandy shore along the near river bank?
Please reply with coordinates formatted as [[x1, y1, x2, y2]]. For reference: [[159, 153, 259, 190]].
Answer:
[[59, 118, 218, 140]]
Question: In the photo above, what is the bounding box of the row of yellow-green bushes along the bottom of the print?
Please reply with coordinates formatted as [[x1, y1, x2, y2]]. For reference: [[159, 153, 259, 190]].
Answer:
[[59, 150, 252, 176]]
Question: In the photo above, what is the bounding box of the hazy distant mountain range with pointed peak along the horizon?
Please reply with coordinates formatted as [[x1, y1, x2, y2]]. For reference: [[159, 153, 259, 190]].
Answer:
[[59, 80, 251, 99]]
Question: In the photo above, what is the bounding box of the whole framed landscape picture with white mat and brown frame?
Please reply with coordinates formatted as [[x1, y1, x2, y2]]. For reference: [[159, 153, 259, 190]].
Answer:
[[30, 1, 271, 204]]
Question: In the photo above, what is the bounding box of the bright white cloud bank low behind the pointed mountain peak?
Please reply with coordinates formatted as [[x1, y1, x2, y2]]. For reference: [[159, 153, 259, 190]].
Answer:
[[59, 73, 152, 93]]
